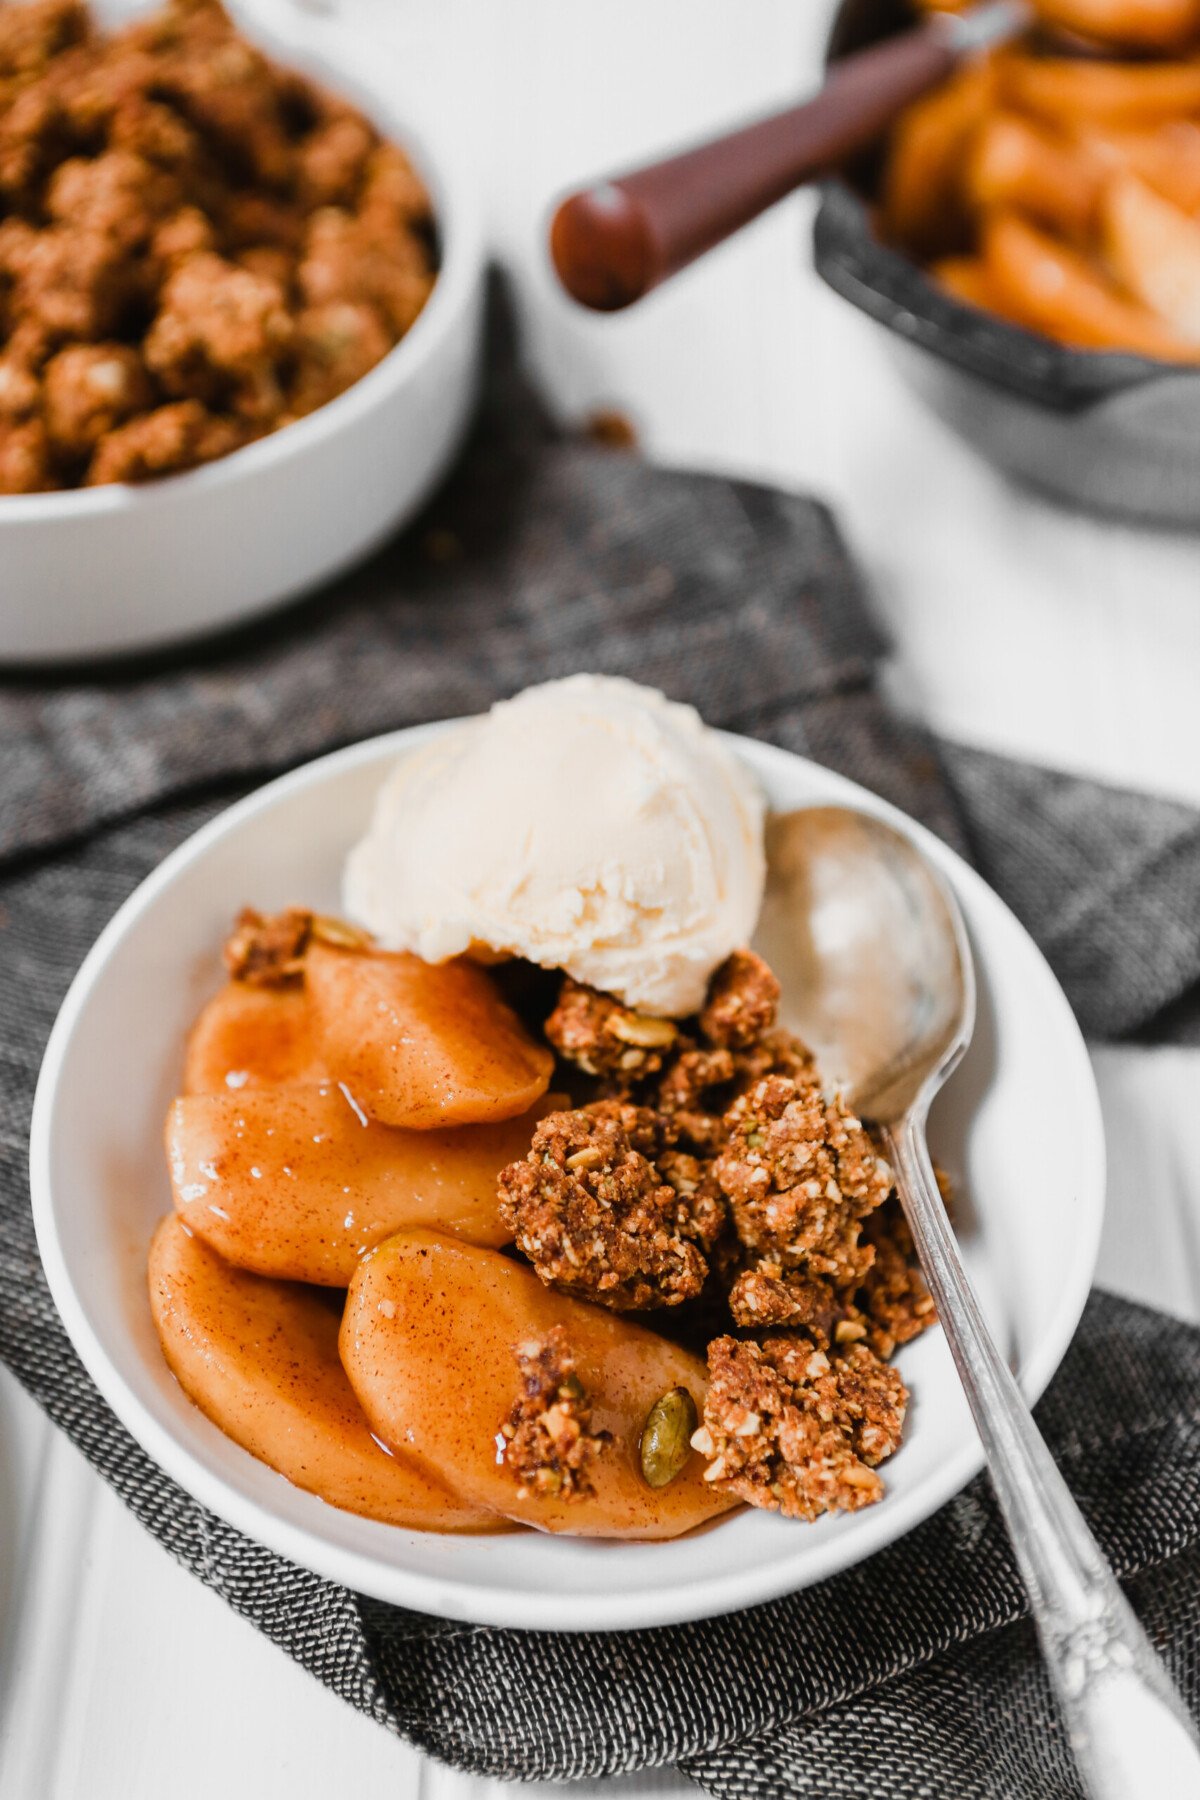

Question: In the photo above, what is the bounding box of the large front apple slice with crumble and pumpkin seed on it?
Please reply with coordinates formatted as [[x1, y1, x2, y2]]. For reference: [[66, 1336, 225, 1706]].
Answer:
[[342, 1231, 736, 1537]]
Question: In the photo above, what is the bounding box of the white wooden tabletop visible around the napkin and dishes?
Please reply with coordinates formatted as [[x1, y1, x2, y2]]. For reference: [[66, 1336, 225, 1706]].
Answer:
[[0, 0, 1200, 1800]]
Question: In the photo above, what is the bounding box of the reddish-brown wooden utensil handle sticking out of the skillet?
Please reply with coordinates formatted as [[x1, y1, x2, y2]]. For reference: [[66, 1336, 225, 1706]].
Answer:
[[551, 18, 961, 313]]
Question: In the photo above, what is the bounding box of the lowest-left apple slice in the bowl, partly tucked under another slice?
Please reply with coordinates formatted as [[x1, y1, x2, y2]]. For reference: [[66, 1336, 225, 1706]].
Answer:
[[149, 1215, 504, 1532]]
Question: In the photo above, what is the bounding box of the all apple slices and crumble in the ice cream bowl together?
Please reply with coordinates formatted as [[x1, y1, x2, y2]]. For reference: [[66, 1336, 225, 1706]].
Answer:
[[149, 907, 934, 1539]]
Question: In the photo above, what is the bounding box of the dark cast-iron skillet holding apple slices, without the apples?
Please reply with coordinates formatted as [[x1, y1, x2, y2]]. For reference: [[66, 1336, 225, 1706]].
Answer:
[[813, 0, 1200, 527]]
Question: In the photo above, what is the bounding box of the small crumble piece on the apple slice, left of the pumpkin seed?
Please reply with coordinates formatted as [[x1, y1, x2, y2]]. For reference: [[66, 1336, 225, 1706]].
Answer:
[[497, 1325, 608, 1499]]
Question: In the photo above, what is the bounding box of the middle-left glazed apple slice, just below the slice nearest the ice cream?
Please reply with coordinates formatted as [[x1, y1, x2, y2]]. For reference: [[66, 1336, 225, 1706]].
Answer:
[[167, 1084, 563, 1287]]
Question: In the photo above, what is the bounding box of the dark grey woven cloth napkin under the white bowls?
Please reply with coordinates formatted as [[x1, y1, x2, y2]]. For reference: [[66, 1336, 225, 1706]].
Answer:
[[0, 288, 1200, 1800]]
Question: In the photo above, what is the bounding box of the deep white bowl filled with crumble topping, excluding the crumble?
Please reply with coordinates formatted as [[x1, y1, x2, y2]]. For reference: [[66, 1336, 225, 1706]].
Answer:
[[0, 14, 484, 664]]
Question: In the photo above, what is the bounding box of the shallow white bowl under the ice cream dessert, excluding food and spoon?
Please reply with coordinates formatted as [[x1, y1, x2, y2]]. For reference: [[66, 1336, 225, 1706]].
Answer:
[[31, 727, 1105, 1631]]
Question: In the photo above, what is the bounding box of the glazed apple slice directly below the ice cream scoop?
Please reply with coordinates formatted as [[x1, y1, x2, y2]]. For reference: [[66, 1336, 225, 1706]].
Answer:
[[304, 943, 554, 1130]]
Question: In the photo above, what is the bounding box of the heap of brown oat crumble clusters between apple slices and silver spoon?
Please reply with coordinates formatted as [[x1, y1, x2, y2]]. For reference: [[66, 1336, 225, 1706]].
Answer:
[[500, 950, 934, 1519]]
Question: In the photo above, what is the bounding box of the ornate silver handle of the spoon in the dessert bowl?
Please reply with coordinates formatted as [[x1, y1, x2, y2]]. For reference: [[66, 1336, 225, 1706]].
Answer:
[[887, 1105, 1200, 1800]]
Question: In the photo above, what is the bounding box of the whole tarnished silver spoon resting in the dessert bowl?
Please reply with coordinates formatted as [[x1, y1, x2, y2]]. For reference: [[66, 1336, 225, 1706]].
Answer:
[[759, 806, 1200, 1800]]
